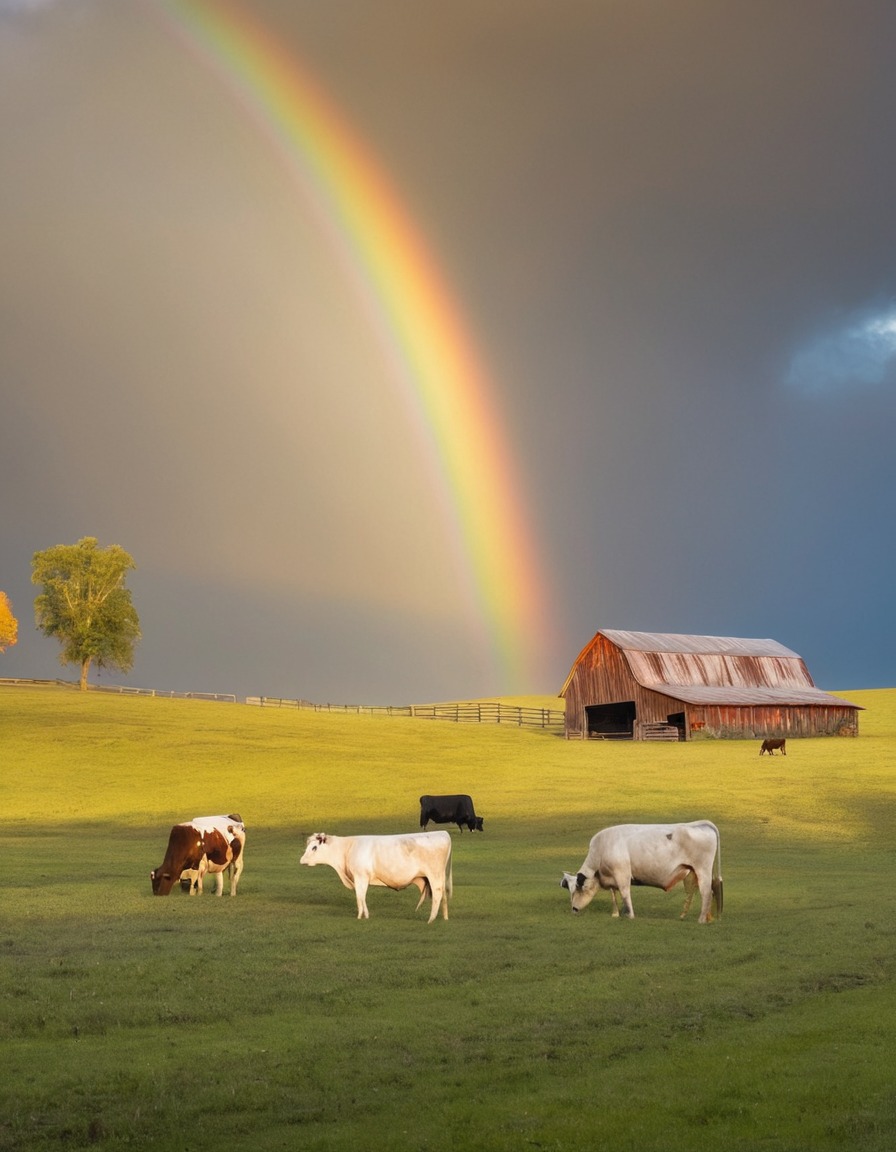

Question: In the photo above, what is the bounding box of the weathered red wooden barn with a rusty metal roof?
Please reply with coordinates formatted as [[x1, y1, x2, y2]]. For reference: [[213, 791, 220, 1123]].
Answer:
[[560, 628, 861, 740]]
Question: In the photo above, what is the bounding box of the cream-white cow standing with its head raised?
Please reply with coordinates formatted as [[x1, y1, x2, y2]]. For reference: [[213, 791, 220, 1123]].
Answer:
[[299, 832, 451, 924]]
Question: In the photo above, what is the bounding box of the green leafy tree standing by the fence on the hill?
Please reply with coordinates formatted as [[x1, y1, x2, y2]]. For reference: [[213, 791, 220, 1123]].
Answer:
[[31, 536, 141, 691]]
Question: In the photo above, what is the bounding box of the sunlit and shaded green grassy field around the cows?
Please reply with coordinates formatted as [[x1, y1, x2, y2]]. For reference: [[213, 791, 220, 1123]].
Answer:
[[0, 688, 896, 1152]]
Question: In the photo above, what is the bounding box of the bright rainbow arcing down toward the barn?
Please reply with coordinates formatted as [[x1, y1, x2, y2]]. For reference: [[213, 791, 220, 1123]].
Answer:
[[162, 0, 549, 692]]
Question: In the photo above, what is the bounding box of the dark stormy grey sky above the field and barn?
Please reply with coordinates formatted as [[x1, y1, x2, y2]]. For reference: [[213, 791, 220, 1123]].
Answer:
[[0, 0, 896, 705]]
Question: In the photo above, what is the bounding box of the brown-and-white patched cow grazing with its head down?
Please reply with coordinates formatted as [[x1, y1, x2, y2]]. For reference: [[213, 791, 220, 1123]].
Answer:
[[150, 816, 245, 896]]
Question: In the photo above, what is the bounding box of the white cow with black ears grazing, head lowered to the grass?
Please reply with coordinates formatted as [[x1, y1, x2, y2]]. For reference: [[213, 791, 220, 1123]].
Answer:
[[560, 820, 722, 924]]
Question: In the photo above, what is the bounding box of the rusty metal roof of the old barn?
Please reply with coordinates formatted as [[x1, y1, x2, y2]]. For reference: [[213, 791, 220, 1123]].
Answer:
[[560, 628, 857, 708]]
